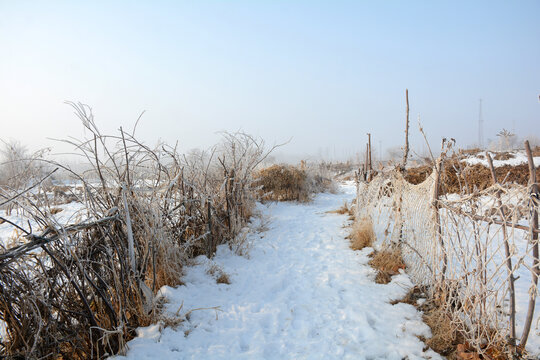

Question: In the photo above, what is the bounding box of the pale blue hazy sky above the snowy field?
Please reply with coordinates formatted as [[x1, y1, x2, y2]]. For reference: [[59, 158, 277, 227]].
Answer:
[[0, 0, 540, 160]]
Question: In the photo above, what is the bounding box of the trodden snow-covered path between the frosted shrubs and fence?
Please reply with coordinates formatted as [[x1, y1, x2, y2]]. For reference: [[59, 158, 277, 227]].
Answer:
[[118, 185, 439, 360]]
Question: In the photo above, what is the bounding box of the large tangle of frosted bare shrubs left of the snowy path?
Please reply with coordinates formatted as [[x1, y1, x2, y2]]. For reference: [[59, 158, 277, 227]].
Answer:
[[0, 104, 272, 359]]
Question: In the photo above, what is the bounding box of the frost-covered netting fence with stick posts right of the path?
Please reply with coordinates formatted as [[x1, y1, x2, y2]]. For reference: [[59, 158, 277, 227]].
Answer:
[[356, 146, 540, 357]]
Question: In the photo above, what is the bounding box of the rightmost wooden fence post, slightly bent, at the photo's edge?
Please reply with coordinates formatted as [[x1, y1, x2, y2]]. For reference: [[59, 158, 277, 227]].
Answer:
[[519, 141, 540, 349]]
